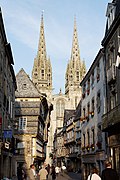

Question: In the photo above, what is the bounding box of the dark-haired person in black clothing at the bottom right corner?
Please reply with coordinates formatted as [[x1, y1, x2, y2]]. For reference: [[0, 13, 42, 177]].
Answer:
[[102, 161, 119, 180]]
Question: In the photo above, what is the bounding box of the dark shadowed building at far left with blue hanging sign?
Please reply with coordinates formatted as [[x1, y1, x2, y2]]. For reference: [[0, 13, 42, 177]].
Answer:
[[0, 9, 16, 179]]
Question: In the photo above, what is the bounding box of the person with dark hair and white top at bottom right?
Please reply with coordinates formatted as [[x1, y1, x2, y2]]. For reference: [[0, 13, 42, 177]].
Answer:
[[87, 167, 101, 180]]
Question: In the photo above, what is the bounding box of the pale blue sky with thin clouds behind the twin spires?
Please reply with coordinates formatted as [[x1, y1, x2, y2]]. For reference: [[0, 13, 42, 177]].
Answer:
[[0, 0, 111, 94]]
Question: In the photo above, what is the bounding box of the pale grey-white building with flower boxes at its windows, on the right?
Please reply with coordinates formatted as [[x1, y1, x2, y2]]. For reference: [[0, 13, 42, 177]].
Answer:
[[80, 49, 106, 179]]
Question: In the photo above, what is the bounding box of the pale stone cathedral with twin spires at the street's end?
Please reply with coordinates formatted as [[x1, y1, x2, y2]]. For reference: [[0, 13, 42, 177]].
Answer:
[[32, 14, 86, 164]]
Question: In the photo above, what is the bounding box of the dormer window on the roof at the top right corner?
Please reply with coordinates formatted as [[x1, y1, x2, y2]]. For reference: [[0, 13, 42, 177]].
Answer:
[[106, 3, 115, 29]]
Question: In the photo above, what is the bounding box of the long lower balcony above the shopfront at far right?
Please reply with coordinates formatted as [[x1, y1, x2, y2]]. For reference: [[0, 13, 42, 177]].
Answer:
[[102, 105, 120, 131]]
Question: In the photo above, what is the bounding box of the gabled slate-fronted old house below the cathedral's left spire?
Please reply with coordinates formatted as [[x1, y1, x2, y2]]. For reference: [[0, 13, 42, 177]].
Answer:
[[14, 69, 52, 174]]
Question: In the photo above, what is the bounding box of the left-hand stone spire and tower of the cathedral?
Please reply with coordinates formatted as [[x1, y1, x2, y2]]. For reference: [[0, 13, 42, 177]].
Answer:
[[32, 14, 52, 96]]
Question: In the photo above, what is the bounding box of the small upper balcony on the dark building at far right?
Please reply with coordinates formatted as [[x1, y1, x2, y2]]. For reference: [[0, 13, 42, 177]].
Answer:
[[107, 64, 116, 84]]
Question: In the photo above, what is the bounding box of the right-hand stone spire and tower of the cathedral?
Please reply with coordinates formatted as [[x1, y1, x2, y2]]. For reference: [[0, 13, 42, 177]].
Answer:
[[65, 18, 86, 95]]
